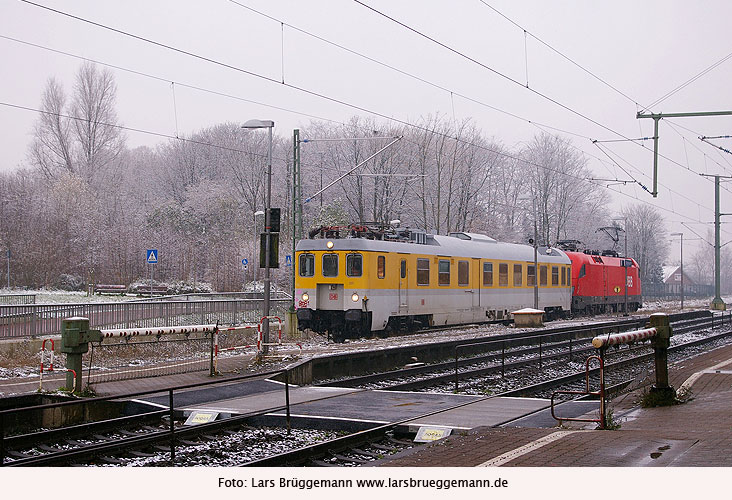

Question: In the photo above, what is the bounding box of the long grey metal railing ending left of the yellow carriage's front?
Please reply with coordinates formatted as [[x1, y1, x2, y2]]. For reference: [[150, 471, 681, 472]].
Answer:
[[0, 298, 292, 338]]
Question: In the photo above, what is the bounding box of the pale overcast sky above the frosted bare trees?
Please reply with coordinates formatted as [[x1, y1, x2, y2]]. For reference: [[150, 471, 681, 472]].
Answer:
[[0, 0, 732, 258]]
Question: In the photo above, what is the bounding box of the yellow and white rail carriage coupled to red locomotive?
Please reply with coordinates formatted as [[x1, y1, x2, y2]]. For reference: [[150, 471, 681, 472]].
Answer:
[[295, 225, 642, 342]]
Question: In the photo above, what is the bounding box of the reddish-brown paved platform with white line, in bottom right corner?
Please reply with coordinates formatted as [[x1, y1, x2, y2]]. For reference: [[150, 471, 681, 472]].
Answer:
[[380, 346, 732, 467]]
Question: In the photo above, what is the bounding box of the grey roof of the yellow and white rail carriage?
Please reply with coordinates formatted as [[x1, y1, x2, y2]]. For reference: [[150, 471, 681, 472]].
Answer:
[[296, 233, 570, 264]]
